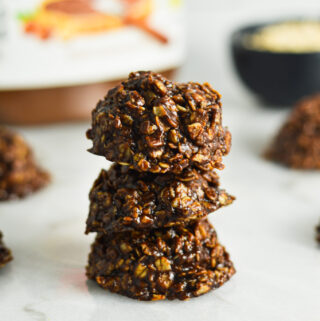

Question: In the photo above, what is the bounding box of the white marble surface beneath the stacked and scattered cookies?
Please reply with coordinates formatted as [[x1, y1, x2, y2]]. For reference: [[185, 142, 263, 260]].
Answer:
[[0, 0, 320, 321]]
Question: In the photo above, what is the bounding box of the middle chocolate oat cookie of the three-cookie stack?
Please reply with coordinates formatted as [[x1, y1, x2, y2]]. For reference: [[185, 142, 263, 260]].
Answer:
[[87, 165, 234, 233]]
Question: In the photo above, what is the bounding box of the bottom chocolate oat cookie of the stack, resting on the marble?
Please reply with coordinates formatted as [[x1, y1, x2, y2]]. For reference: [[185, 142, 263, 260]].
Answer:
[[87, 219, 235, 301]]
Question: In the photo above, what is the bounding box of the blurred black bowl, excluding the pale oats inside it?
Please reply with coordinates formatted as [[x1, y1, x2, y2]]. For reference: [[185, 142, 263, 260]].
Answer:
[[231, 21, 320, 106]]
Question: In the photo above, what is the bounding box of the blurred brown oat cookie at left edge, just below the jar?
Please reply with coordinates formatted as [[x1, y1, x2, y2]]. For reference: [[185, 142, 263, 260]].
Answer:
[[0, 127, 49, 201]]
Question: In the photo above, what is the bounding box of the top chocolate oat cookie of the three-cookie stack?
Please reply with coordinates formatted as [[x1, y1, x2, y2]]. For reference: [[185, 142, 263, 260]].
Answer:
[[87, 72, 231, 173]]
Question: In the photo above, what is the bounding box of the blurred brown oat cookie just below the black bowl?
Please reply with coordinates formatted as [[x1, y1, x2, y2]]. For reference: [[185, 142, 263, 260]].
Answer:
[[266, 94, 320, 169]]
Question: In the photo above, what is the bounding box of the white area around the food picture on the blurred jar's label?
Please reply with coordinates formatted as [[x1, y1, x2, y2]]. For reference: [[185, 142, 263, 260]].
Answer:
[[0, 0, 185, 90]]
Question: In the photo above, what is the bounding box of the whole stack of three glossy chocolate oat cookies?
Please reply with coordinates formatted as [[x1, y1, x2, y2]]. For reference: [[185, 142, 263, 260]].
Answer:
[[86, 72, 235, 300]]
